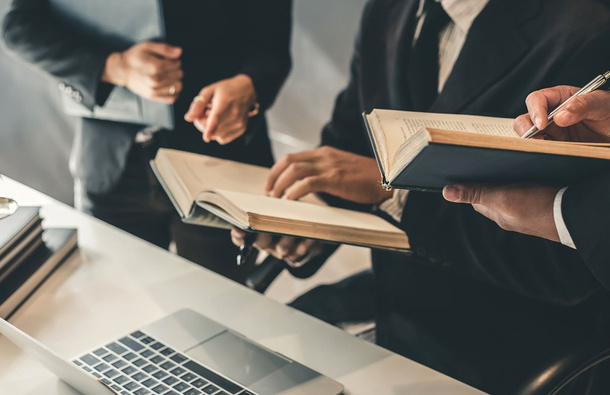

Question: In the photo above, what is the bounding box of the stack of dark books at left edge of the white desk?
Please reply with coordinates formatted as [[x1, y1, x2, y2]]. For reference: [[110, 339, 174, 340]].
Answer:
[[0, 207, 77, 319]]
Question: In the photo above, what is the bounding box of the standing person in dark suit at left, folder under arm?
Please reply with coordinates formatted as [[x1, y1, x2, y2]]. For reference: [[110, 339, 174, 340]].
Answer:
[[2, 0, 292, 281]]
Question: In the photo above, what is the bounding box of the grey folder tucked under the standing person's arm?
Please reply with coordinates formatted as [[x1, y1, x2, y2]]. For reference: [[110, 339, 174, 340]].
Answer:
[[49, 0, 174, 129]]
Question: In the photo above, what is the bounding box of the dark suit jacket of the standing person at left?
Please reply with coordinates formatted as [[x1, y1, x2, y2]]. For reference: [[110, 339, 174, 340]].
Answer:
[[3, 0, 292, 193]]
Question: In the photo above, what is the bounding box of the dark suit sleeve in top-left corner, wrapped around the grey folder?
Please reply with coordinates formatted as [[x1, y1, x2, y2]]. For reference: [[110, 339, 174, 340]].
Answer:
[[2, 0, 112, 109]]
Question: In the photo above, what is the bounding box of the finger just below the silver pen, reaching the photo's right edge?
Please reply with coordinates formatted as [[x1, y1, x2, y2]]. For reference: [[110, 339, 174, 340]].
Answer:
[[554, 91, 610, 127]]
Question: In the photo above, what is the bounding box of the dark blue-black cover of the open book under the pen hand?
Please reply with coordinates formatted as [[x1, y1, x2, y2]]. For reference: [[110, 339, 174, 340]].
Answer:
[[389, 143, 610, 191]]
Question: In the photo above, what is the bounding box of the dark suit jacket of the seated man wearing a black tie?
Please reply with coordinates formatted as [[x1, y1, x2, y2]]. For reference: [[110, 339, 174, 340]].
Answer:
[[322, 0, 610, 305]]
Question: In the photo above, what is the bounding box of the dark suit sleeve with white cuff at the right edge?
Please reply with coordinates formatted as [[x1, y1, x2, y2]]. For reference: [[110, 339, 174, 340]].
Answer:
[[561, 174, 610, 290]]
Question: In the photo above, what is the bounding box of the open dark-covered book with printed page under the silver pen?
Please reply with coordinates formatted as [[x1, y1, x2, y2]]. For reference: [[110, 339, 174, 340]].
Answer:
[[363, 109, 610, 191]]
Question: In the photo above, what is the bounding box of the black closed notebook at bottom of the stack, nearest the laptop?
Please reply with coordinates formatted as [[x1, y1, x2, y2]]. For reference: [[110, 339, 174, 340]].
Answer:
[[0, 229, 77, 319]]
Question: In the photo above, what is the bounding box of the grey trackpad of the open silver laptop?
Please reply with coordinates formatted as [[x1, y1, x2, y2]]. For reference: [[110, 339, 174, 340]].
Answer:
[[185, 331, 290, 386]]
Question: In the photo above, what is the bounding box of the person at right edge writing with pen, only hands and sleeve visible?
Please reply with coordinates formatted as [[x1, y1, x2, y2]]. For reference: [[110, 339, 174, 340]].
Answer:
[[443, 86, 610, 289]]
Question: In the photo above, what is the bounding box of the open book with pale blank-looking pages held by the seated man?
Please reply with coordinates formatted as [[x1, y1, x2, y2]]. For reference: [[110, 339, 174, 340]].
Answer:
[[152, 149, 409, 251]]
